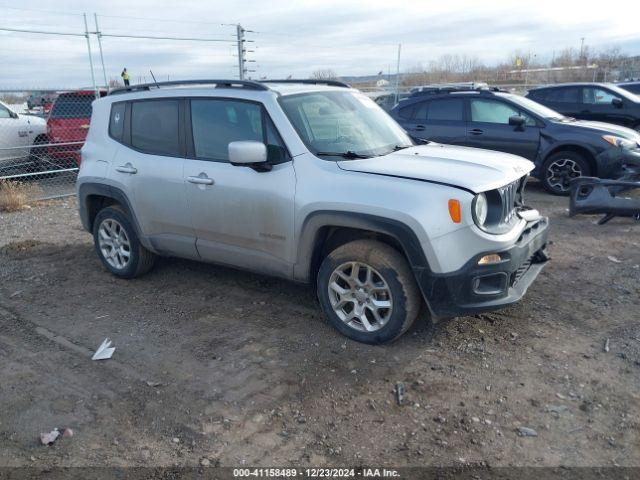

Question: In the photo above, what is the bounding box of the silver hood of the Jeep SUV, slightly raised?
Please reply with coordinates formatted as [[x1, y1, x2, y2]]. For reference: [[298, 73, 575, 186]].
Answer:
[[338, 143, 533, 193]]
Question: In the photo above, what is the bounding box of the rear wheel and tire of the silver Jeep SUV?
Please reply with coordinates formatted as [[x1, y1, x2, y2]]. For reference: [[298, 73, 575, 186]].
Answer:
[[93, 205, 156, 278]]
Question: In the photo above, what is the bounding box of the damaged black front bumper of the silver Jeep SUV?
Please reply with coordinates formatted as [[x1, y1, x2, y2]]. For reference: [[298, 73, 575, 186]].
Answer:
[[414, 217, 549, 318]]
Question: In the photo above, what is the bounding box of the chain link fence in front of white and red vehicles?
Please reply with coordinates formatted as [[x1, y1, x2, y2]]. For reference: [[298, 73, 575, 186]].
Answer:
[[0, 88, 106, 200]]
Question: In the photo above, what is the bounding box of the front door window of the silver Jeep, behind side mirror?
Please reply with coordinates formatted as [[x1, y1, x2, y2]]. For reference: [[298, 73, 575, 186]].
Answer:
[[191, 99, 288, 164]]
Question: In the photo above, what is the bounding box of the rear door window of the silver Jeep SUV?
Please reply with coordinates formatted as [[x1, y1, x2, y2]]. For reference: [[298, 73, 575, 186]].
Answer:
[[131, 100, 180, 157]]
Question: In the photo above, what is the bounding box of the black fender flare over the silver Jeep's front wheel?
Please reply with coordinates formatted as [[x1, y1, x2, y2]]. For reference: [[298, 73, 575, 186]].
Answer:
[[293, 210, 431, 283]]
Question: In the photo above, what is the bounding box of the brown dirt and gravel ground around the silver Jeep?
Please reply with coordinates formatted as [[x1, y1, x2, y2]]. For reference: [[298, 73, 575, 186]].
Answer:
[[0, 185, 640, 467]]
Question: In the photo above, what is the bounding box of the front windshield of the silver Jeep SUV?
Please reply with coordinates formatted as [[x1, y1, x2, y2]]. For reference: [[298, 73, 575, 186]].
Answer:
[[280, 91, 413, 158]]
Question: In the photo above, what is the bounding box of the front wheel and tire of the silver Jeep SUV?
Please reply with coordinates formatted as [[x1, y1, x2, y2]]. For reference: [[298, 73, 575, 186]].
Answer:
[[317, 240, 422, 344]]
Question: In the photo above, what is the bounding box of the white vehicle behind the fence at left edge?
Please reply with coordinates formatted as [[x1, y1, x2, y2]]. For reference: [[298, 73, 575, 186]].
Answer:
[[0, 102, 47, 171]]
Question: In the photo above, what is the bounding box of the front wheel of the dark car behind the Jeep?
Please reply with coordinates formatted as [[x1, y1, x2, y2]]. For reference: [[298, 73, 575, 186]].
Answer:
[[541, 150, 591, 195]]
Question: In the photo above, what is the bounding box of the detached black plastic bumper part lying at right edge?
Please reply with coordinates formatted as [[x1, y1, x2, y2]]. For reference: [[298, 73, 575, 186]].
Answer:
[[569, 177, 640, 225]]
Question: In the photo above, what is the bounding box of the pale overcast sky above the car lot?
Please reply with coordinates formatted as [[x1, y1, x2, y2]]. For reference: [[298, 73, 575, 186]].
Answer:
[[0, 0, 640, 89]]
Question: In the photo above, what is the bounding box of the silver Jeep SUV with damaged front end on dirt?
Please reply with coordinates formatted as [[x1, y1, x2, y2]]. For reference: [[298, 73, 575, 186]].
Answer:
[[78, 80, 548, 343]]
